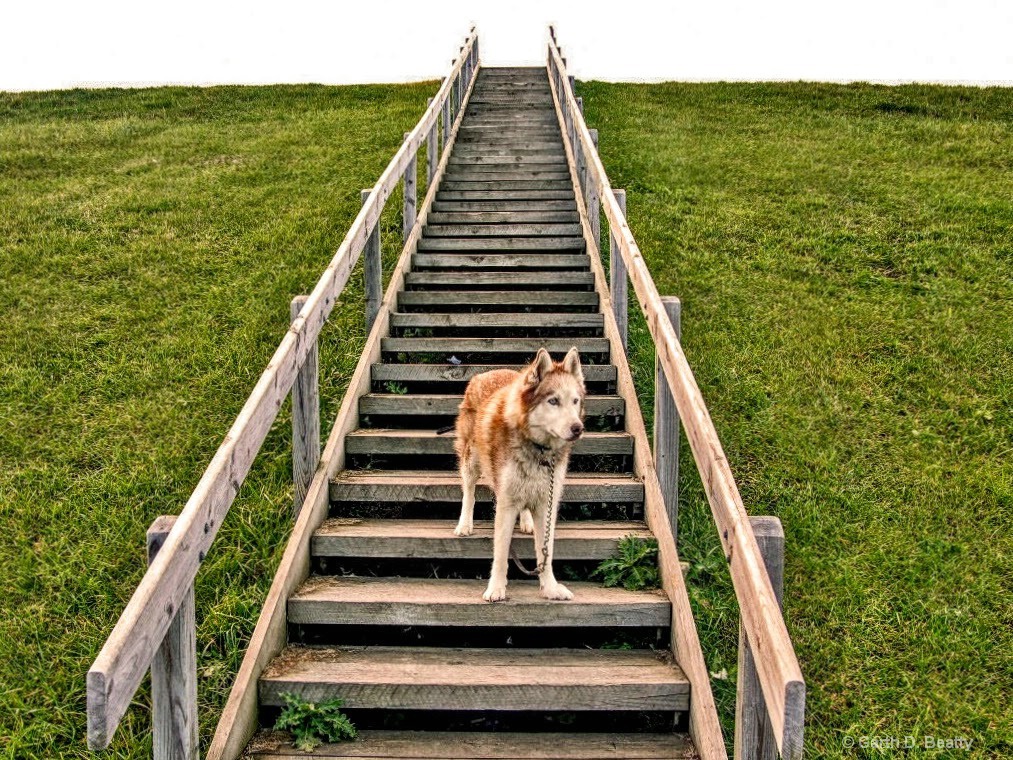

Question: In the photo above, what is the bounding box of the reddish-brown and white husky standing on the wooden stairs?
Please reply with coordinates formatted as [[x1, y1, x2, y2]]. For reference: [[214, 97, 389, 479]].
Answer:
[[454, 348, 587, 602]]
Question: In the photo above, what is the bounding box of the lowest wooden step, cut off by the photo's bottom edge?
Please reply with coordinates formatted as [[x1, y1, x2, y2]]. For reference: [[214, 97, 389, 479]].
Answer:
[[247, 731, 697, 760]]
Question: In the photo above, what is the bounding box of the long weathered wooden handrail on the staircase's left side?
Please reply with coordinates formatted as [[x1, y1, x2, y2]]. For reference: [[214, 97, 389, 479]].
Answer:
[[87, 27, 478, 750]]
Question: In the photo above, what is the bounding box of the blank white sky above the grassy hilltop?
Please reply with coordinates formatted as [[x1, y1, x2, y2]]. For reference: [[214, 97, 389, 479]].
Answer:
[[0, 0, 1013, 90]]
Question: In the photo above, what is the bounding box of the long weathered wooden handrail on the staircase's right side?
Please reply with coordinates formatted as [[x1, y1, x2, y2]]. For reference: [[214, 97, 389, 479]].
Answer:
[[548, 30, 805, 758]]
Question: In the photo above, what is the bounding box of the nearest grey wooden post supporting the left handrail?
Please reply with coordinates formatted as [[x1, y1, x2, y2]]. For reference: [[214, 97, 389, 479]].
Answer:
[[148, 515, 199, 760]]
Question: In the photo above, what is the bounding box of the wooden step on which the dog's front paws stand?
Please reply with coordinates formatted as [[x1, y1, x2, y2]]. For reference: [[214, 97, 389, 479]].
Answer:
[[288, 579, 672, 627]]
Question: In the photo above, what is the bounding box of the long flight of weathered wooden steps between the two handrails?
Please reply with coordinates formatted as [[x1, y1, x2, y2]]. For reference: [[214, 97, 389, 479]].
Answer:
[[241, 67, 696, 759]]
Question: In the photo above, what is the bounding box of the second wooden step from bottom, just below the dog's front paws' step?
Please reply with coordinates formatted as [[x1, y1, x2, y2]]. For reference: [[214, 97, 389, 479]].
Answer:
[[259, 648, 690, 710]]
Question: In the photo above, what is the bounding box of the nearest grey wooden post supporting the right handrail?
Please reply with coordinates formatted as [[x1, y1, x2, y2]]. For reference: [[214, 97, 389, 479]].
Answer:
[[734, 517, 802, 760]]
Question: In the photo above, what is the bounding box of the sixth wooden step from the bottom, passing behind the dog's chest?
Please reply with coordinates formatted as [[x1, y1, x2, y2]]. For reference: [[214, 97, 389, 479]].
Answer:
[[344, 428, 633, 456]]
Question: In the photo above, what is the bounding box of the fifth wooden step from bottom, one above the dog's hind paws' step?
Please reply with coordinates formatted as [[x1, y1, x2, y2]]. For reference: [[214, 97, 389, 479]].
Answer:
[[330, 470, 643, 506]]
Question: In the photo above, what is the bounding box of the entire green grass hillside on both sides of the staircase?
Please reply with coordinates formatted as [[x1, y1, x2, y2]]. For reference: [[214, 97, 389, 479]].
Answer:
[[0, 83, 1013, 758]]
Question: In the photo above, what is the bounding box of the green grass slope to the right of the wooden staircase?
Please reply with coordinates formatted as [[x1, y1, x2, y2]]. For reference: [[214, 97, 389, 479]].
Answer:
[[579, 83, 1013, 758]]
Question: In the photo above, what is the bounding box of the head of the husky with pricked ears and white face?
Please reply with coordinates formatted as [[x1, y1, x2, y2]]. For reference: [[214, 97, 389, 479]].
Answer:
[[522, 348, 587, 446]]
